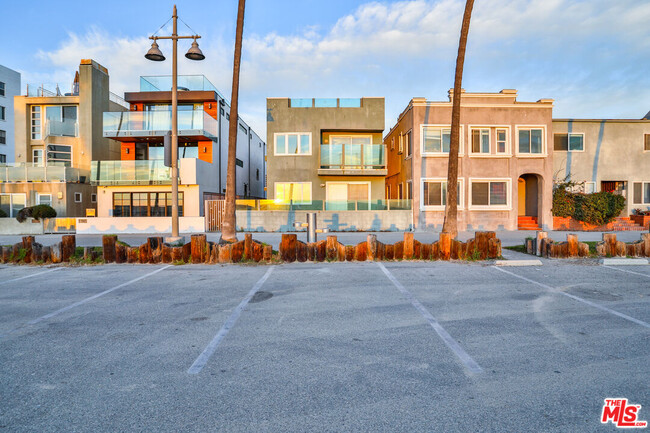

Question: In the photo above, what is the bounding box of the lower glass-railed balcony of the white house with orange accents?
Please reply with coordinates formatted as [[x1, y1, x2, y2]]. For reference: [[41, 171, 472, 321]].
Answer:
[[90, 158, 210, 186]]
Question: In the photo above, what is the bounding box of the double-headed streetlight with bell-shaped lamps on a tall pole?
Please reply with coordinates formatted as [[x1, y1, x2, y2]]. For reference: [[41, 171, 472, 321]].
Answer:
[[145, 5, 205, 242]]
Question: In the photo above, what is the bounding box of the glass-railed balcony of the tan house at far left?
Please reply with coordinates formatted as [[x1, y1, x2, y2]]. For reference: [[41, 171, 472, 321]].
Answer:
[[0, 163, 89, 183]]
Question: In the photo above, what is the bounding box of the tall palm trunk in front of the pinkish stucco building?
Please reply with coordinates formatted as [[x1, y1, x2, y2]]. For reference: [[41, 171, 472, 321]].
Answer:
[[442, 0, 474, 238]]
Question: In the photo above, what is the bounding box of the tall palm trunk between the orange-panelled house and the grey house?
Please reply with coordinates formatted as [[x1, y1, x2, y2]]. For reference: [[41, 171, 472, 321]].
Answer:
[[221, 0, 246, 242]]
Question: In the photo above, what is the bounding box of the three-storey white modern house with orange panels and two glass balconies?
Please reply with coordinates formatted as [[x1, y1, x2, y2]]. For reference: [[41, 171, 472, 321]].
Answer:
[[91, 75, 266, 217]]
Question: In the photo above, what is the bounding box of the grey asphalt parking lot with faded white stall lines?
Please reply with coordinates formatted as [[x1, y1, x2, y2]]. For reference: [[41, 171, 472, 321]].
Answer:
[[0, 262, 650, 432]]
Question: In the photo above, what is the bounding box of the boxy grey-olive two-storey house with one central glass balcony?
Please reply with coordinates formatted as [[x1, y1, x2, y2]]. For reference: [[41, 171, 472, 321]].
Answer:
[[266, 98, 387, 210]]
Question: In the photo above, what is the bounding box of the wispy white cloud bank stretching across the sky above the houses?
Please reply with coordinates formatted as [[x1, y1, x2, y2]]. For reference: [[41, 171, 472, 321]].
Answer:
[[26, 0, 650, 134]]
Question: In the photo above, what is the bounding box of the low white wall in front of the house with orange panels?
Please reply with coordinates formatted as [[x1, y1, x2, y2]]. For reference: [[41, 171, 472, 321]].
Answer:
[[77, 217, 205, 235]]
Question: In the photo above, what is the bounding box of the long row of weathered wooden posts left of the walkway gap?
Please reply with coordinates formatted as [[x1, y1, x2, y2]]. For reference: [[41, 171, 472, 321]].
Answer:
[[0, 232, 501, 264]]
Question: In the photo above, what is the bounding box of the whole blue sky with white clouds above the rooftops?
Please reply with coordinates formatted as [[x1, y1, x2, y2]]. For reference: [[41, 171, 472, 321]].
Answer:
[[0, 0, 650, 137]]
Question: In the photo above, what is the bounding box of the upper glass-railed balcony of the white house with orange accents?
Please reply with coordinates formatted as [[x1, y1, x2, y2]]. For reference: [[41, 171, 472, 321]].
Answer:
[[103, 110, 219, 141]]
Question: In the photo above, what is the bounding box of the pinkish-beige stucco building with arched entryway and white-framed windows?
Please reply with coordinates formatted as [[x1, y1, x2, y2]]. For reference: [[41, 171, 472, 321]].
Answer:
[[384, 90, 553, 230]]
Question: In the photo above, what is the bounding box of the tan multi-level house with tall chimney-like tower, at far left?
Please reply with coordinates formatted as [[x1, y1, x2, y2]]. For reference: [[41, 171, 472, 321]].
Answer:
[[0, 59, 127, 217]]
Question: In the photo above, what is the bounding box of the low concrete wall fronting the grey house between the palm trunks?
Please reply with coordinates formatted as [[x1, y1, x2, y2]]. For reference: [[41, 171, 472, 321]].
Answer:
[[237, 210, 413, 232]]
